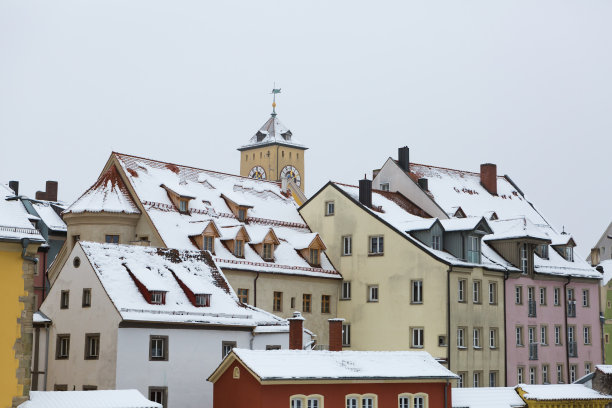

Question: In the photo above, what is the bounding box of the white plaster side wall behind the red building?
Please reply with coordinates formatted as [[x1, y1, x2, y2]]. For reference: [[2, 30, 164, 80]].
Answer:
[[117, 328, 289, 408]]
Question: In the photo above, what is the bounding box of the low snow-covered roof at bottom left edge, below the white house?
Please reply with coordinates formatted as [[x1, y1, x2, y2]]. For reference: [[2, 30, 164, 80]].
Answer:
[[18, 390, 162, 408]]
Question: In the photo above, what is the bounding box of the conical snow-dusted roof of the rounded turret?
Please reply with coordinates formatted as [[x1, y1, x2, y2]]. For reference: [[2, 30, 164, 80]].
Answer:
[[65, 166, 140, 214]]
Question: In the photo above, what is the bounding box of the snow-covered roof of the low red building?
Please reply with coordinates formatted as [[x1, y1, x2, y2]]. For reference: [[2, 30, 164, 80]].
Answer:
[[233, 349, 458, 380]]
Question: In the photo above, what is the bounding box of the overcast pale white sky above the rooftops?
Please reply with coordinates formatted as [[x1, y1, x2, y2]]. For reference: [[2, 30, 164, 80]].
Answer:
[[0, 0, 612, 256]]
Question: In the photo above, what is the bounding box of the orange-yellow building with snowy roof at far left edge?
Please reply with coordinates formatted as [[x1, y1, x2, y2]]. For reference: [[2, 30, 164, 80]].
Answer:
[[0, 184, 44, 408]]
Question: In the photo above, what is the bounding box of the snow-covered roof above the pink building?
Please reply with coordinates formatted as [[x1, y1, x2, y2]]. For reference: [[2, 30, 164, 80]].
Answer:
[[410, 163, 600, 279]]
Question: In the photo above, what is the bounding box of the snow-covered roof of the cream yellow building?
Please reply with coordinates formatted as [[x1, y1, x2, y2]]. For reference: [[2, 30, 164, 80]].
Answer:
[[334, 183, 518, 271]]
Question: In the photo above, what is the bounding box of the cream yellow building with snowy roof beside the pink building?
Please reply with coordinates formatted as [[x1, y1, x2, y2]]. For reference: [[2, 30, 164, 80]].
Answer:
[[300, 180, 505, 386]]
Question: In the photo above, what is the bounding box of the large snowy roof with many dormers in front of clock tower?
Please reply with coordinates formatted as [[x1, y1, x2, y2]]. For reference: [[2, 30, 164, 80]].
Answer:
[[113, 153, 341, 279]]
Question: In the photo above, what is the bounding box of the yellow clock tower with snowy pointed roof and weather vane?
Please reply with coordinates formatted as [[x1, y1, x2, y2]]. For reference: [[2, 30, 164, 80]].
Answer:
[[238, 89, 308, 192]]
